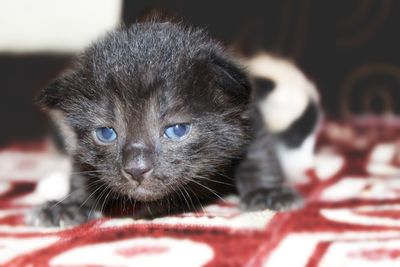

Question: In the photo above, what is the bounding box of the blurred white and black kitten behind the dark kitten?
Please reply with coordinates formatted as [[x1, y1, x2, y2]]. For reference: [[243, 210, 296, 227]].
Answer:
[[243, 53, 323, 183]]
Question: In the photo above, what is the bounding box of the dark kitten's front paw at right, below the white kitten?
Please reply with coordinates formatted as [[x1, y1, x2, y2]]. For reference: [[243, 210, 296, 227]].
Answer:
[[242, 187, 304, 211]]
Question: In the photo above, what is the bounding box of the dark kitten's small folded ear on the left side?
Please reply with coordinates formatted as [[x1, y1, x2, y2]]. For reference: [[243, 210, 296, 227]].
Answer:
[[36, 80, 64, 109]]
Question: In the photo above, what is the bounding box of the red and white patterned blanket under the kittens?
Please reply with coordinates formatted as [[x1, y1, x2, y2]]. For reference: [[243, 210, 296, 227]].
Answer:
[[0, 118, 400, 267]]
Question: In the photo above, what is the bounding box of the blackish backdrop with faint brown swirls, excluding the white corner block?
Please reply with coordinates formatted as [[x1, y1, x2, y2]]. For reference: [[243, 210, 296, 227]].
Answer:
[[0, 0, 400, 145]]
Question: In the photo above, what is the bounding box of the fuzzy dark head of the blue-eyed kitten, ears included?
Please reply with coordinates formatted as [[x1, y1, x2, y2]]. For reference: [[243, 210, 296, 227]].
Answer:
[[39, 22, 250, 201]]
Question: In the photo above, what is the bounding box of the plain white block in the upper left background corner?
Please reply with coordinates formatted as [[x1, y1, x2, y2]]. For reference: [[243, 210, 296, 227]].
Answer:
[[0, 0, 122, 53]]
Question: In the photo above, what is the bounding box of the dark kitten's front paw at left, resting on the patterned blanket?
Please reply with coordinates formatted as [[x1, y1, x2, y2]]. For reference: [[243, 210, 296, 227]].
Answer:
[[25, 201, 101, 228]]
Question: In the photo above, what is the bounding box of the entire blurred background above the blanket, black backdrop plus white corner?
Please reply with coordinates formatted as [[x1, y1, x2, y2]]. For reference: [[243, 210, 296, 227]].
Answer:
[[0, 0, 400, 146]]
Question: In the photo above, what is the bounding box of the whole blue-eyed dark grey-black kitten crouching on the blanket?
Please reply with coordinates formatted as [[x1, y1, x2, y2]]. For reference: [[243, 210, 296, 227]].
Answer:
[[28, 22, 298, 226]]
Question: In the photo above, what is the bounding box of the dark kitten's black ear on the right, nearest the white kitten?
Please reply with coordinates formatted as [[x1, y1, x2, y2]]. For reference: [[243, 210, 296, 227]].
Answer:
[[212, 55, 251, 104]]
